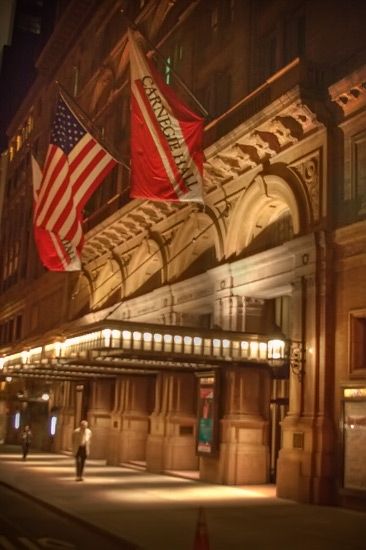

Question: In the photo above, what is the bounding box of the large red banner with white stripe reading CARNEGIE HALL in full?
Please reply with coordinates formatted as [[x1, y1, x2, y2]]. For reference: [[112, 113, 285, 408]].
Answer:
[[129, 30, 204, 202]]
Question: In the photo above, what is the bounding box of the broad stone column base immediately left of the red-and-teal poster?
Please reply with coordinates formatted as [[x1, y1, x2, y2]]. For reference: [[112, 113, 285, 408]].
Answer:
[[146, 373, 198, 472]]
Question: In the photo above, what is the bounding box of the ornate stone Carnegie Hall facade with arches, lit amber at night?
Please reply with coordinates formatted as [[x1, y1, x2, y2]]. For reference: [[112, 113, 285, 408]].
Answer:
[[0, 0, 366, 505]]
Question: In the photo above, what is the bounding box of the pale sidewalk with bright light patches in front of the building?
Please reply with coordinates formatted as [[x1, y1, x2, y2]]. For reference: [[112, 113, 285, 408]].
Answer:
[[0, 446, 366, 550]]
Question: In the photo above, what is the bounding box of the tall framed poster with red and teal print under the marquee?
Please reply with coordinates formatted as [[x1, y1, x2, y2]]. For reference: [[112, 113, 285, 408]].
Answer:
[[196, 372, 219, 456]]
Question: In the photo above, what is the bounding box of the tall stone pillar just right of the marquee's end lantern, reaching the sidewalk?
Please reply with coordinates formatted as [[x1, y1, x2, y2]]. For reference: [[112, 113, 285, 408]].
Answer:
[[277, 235, 335, 504]]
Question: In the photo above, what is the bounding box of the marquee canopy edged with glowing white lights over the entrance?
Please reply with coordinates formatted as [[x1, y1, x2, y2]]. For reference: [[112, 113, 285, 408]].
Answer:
[[0, 320, 289, 380]]
